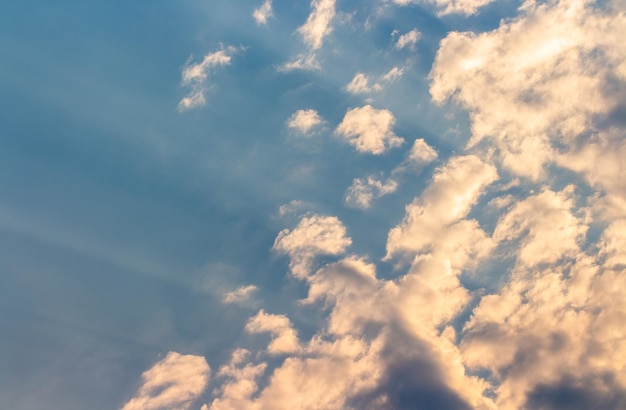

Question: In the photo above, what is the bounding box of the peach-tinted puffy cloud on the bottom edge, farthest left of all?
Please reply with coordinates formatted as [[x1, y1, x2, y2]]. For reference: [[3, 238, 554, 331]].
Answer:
[[122, 352, 210, 410]]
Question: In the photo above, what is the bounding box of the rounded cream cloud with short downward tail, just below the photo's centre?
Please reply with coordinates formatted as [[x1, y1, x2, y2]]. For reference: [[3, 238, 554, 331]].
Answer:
[[273, 214, 352, 277]]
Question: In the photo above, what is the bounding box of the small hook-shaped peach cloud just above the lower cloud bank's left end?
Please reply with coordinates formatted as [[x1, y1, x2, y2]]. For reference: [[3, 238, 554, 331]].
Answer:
[[246, 309, 300, 355]]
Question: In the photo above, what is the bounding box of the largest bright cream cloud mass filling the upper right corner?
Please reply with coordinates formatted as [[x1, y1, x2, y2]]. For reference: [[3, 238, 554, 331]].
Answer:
[[430, 0, 626, 179]]
